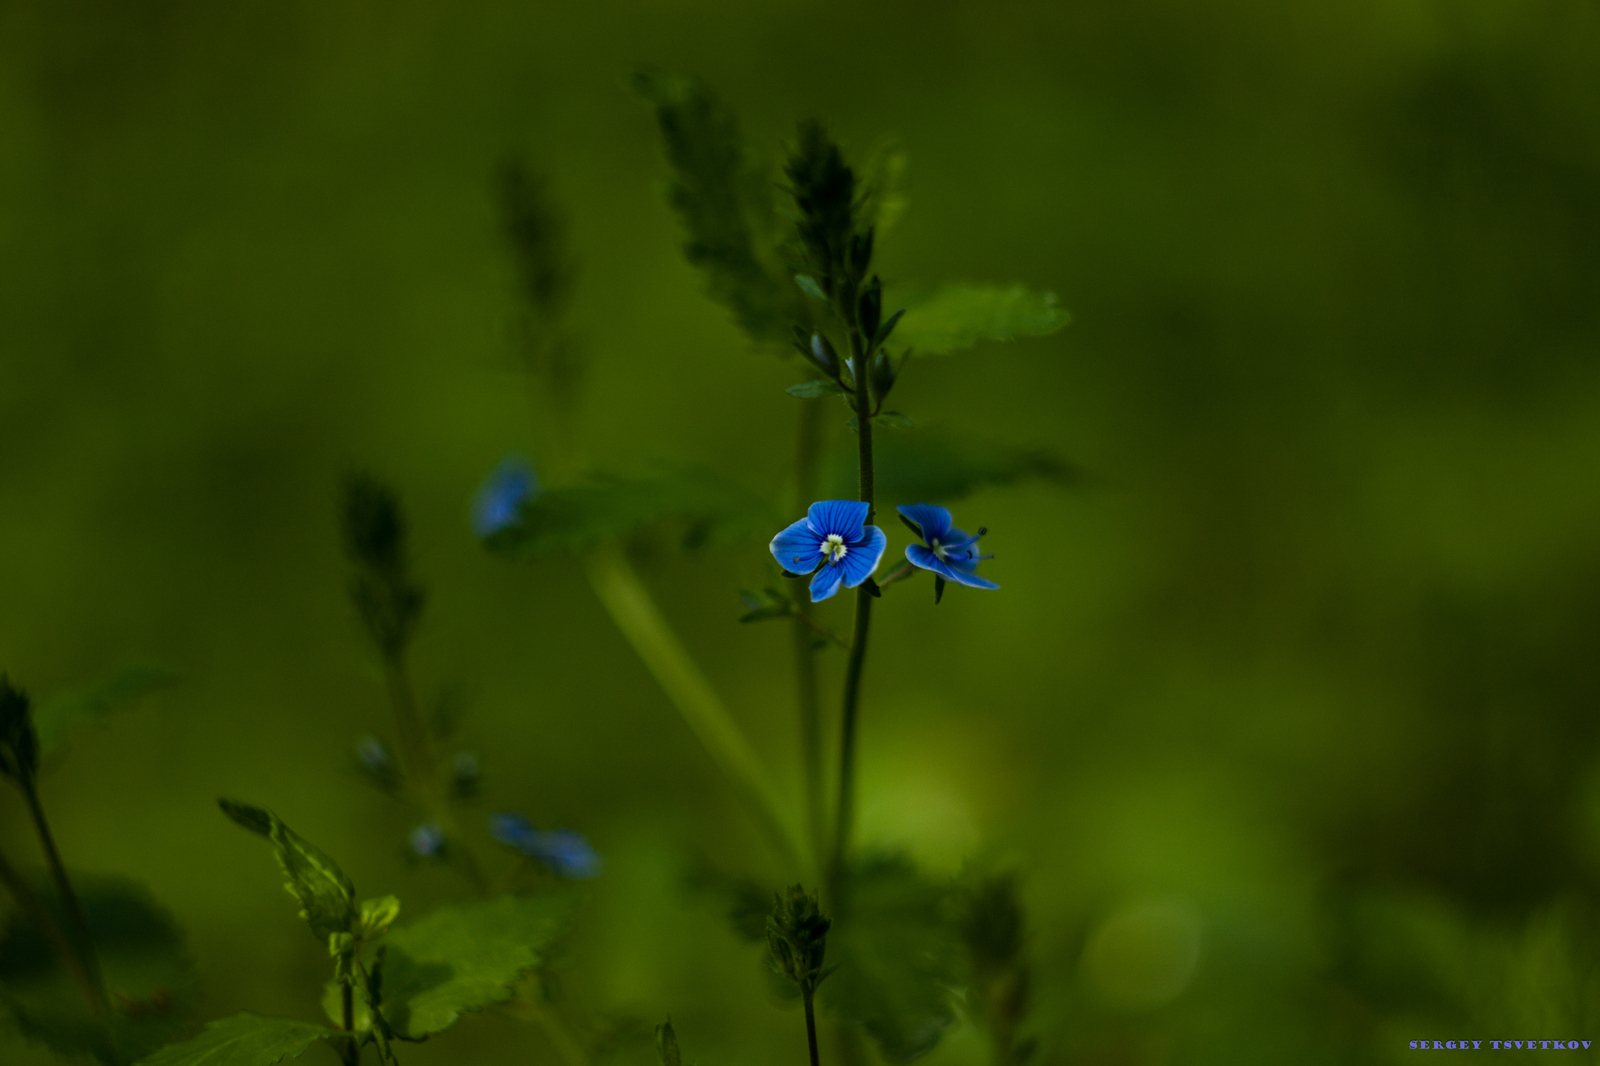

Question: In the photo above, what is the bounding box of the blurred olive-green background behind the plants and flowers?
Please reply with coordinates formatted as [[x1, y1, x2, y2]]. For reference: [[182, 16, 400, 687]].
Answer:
[[0, 0, 1600, 1066]]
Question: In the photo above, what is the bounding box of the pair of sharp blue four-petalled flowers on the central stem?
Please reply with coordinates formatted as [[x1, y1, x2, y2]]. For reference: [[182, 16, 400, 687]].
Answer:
[[770, 499, 1000, 603]]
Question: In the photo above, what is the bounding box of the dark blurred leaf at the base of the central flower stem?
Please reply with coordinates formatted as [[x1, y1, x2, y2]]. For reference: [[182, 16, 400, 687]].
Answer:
[[819, 855, 958, 1063]]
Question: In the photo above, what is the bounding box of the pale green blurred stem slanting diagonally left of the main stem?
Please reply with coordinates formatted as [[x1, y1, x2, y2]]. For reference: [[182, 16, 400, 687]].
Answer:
[[587, 544, 800, 866]]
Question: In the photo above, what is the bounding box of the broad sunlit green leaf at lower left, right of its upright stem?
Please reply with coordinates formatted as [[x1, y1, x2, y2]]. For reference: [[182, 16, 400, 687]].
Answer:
[[323, 896, 576, 1040]]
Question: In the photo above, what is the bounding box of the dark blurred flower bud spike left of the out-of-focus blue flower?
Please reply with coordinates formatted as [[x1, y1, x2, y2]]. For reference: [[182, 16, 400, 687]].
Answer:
[[342, 474, 424, 656]]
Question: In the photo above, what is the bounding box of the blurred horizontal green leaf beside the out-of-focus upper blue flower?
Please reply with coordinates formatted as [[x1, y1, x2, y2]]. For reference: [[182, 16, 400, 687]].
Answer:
[[485, 467, 781, 559]]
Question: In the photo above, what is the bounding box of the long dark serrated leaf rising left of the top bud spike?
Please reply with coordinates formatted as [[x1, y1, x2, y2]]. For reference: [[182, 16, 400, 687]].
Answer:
[[634, 72, 796, 346]]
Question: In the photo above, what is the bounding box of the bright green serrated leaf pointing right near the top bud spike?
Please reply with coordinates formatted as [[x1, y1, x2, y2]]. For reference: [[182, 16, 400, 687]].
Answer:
[[894, 285, 1070, 355]]
